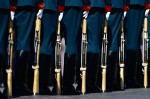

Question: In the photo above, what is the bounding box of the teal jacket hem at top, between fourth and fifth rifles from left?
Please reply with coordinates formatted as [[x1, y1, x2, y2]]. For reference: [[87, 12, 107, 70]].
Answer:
[[90, 0, 105, 8]]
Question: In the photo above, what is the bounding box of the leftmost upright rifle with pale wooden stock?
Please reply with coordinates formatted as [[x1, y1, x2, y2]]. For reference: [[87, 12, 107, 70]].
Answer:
[[6, 19, 14, 99]]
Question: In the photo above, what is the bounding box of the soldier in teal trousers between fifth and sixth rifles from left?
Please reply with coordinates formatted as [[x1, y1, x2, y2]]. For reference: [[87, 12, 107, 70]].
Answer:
[[106, 0, 127, 91]]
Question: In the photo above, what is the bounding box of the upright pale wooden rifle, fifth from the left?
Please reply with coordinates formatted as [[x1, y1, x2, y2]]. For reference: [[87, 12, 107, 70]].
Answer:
[[101, 19, 108, 93]]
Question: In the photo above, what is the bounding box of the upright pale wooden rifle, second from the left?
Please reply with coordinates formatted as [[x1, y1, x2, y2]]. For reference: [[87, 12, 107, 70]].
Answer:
[[32, 17, 41, 95]]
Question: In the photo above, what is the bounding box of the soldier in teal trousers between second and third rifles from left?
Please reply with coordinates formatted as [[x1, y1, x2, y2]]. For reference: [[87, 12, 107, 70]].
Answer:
[[35, 0, 64, 95]]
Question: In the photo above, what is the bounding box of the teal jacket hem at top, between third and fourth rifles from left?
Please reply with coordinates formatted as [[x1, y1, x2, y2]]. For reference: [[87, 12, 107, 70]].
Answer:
[[65, 0, 90, 7]]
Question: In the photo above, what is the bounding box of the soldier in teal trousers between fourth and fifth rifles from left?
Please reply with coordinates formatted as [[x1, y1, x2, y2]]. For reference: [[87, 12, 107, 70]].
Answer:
[[86, 0, 105, 93]]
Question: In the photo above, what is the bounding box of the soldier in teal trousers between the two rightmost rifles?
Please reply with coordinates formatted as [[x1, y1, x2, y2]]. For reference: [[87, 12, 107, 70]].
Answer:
[[126, 0, 146, 88]]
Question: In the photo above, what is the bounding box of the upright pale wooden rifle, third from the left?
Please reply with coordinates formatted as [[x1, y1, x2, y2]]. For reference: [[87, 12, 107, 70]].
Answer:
[[55, 21, 61, 95]]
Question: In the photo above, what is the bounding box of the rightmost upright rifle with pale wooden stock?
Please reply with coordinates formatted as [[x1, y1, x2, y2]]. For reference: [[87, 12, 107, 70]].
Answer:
[[142, 18, 148, 88]]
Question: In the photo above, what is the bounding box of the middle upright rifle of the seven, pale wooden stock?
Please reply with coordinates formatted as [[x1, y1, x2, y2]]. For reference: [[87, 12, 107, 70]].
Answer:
[[80, 18, 87, 95]]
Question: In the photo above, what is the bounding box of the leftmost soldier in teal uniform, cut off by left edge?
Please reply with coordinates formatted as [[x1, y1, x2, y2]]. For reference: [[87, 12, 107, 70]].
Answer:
[[0, 0, 16, 98]]
